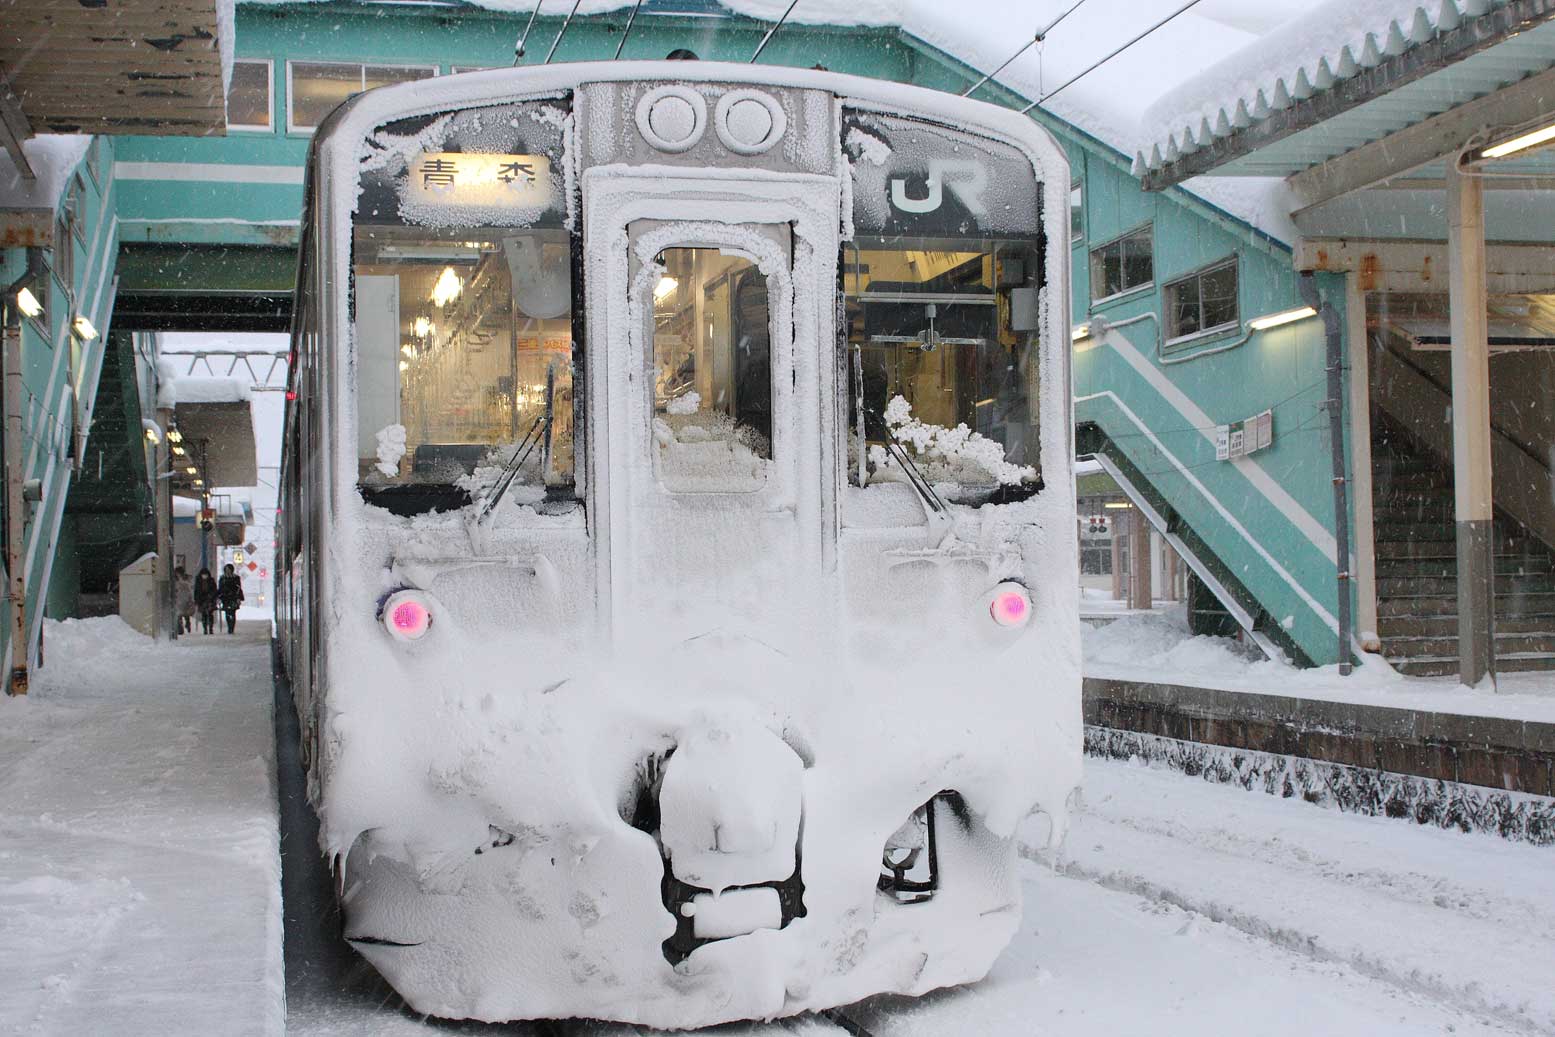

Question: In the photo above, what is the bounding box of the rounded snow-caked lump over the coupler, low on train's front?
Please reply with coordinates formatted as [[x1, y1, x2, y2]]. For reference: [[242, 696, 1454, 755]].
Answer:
[[659, 720, 804, 894]]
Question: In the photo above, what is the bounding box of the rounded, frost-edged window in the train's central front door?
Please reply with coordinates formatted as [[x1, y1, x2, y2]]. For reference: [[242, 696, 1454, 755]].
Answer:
[[652, 247, 773, 493]]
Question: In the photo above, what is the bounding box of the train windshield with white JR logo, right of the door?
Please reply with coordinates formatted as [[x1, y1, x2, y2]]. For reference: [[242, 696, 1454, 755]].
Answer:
[[840, 112, 1047, 504]]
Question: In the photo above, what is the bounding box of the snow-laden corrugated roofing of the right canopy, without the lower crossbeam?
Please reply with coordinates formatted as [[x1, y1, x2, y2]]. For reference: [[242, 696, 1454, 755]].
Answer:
[[1134, 0, 1555, 190]]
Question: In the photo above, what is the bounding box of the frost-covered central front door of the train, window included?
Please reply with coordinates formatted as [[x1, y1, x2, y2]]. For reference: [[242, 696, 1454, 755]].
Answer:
[[589, 180, 837, 644]]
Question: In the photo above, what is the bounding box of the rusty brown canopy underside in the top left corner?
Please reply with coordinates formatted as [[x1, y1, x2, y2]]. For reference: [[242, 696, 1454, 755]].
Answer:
[[0, 0, 233, 179]]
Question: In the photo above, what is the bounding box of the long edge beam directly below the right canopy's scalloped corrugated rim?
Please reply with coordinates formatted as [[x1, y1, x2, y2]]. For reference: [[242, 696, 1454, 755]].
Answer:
[[1141, 0, 1555, 191]]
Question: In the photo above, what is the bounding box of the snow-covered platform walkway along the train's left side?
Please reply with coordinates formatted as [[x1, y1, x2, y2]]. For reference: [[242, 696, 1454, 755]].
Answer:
[[0, 616, 285, 1035]]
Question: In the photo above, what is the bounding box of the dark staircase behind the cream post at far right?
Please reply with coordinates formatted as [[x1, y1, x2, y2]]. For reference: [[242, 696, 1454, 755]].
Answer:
[[1372, 409, 1555, 676]]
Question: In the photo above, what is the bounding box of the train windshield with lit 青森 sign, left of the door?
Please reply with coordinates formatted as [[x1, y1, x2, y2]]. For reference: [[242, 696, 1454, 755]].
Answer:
[[351, 101, 578, 515]]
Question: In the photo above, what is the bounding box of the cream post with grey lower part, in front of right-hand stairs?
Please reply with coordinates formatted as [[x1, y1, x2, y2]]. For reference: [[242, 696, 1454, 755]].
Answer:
[[1446, 157, 1496, 687]]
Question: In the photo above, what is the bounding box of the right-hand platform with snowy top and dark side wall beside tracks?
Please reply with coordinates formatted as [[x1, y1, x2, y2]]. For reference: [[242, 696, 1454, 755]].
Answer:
[[1084, 613, 1555, 844]]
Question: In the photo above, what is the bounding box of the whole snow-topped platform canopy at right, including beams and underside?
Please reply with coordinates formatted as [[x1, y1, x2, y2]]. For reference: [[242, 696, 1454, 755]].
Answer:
[[1135, 0, 1555, 244]]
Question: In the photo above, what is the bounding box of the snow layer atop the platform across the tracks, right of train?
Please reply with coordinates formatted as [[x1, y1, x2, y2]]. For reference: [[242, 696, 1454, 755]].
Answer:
[[1082, 608, 1555, 723]]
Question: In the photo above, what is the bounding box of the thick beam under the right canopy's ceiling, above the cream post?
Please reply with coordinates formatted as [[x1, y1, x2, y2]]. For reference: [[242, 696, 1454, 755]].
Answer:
[[1286, 68, 1555, 216]]
